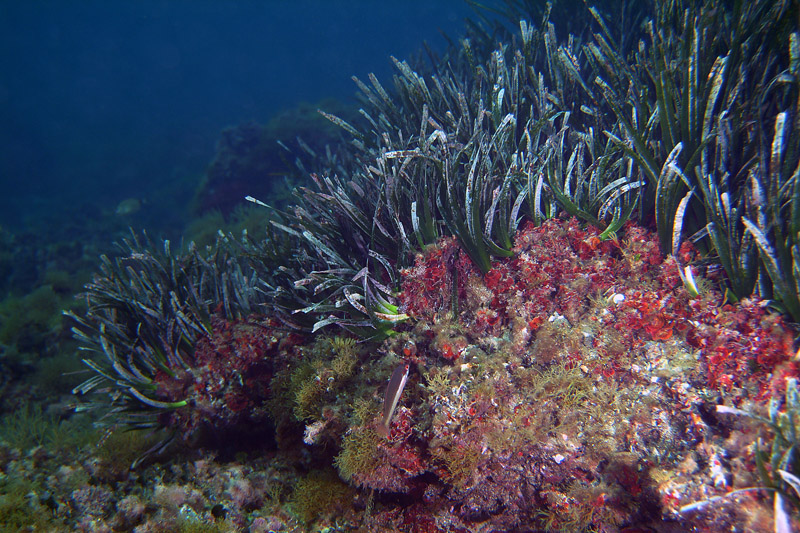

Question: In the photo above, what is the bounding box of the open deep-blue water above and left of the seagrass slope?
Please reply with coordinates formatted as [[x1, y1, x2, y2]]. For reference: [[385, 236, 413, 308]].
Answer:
[[0, 0, 478, 233]]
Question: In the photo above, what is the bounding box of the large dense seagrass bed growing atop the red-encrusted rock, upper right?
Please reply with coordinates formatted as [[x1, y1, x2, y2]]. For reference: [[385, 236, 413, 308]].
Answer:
[[268, 0, 800, 333]]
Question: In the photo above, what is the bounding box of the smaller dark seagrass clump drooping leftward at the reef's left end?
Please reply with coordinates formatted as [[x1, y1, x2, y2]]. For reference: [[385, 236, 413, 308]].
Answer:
[[67, 234, 261, 436]]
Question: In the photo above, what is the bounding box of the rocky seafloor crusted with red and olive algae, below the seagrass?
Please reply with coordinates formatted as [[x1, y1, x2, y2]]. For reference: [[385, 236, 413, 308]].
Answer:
[[0, 214, 798, 533]]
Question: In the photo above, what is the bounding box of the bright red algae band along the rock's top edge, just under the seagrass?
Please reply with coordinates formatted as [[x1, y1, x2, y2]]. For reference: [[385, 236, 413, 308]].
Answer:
[[401, 218, 796, 397]]
